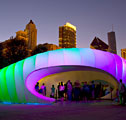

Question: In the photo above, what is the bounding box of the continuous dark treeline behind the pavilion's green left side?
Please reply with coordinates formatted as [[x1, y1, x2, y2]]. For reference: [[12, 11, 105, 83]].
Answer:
[[0, 38, 48, 69]]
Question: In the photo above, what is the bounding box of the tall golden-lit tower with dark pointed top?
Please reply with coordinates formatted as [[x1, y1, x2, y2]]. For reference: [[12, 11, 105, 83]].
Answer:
[[24, 20, 37, 50]]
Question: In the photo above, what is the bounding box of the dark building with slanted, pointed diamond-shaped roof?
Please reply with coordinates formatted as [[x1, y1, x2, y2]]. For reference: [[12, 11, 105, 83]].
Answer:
[[90, 37, 109, 51]]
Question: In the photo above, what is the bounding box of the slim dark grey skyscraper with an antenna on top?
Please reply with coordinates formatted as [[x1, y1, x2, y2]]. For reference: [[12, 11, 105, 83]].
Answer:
[[108, 31, 117, 54]]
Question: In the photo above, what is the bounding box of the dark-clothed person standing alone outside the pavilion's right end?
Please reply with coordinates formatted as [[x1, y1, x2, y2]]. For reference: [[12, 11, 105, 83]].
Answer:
[[119, 79, 126, 105]]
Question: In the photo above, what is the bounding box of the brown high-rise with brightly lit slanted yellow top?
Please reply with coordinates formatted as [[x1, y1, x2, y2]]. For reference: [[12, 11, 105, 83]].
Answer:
[[59, 22, 76, 48]]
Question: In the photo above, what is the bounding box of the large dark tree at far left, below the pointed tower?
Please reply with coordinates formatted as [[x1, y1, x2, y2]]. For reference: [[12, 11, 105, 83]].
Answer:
[[1, 38, 30, 67]]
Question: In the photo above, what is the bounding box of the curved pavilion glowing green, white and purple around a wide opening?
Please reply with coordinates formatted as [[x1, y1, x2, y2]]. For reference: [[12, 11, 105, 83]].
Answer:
[[0, 48, 126, 103]]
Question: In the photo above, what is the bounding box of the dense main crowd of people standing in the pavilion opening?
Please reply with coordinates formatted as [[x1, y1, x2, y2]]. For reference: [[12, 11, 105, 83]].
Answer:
[[58, 80, 105, 101]]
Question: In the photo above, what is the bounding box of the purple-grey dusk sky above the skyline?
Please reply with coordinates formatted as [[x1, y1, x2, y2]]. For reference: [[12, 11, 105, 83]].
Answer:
[[0, 0, 126, 55]]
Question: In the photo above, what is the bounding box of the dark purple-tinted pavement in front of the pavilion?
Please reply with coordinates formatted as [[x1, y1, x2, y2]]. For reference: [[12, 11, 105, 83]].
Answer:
[[0, 101, 126, 120]]
